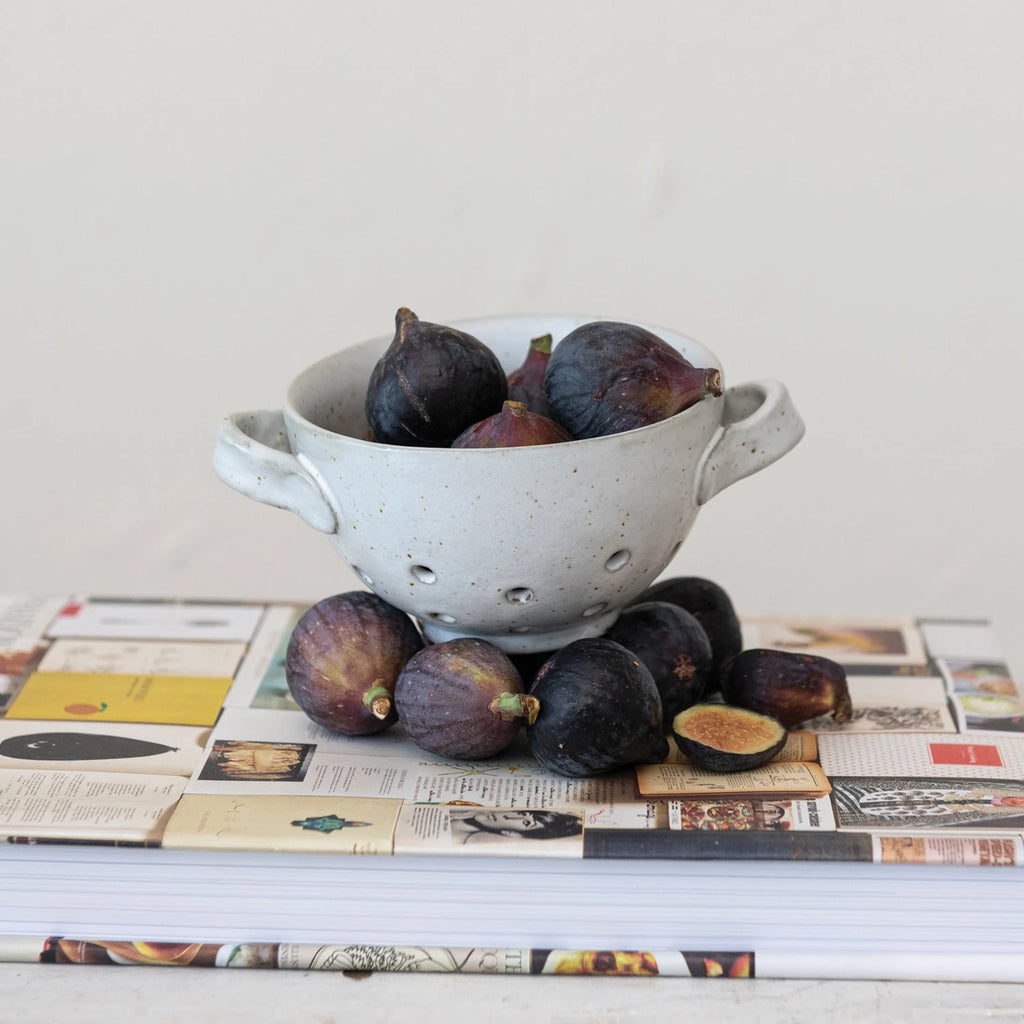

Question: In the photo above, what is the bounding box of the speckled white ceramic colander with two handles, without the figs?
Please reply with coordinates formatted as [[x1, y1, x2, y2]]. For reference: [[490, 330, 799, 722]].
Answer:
[[214, 314, 804, 652]]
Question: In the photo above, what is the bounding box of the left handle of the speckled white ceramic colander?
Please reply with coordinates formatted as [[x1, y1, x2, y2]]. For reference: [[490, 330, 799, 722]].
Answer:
[[213, 412, 338, 534]]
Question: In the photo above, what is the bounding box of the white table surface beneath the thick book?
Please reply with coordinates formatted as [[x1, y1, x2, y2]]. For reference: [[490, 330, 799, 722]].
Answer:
[[6, 964, 1024, 1024]]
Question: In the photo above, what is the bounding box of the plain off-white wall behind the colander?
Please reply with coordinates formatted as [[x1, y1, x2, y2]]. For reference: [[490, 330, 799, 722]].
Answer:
[[0, 6, 1024, 678]]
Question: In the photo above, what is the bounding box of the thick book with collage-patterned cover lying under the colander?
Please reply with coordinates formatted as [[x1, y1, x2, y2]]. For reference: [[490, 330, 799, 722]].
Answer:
[[0, 595, 1024, 981]]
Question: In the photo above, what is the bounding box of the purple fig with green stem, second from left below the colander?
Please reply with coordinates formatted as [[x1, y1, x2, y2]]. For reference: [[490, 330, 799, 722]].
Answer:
[[394, 637, 537, 761]]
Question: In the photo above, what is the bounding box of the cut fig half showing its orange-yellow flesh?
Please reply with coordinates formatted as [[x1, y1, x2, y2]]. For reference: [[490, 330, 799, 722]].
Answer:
[[672, 703, 788, 772]]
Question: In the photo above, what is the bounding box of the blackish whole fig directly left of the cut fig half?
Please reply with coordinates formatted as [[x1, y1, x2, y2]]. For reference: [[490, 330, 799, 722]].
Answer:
[[526, 637, 669, 778]]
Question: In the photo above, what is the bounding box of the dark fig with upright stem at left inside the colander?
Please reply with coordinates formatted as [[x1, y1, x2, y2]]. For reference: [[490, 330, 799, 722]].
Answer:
[[366, 306, 508, 447]]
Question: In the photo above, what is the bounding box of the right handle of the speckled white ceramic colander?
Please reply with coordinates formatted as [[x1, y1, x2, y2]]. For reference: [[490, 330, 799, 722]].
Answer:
[[697, 381, 805, 505]]
